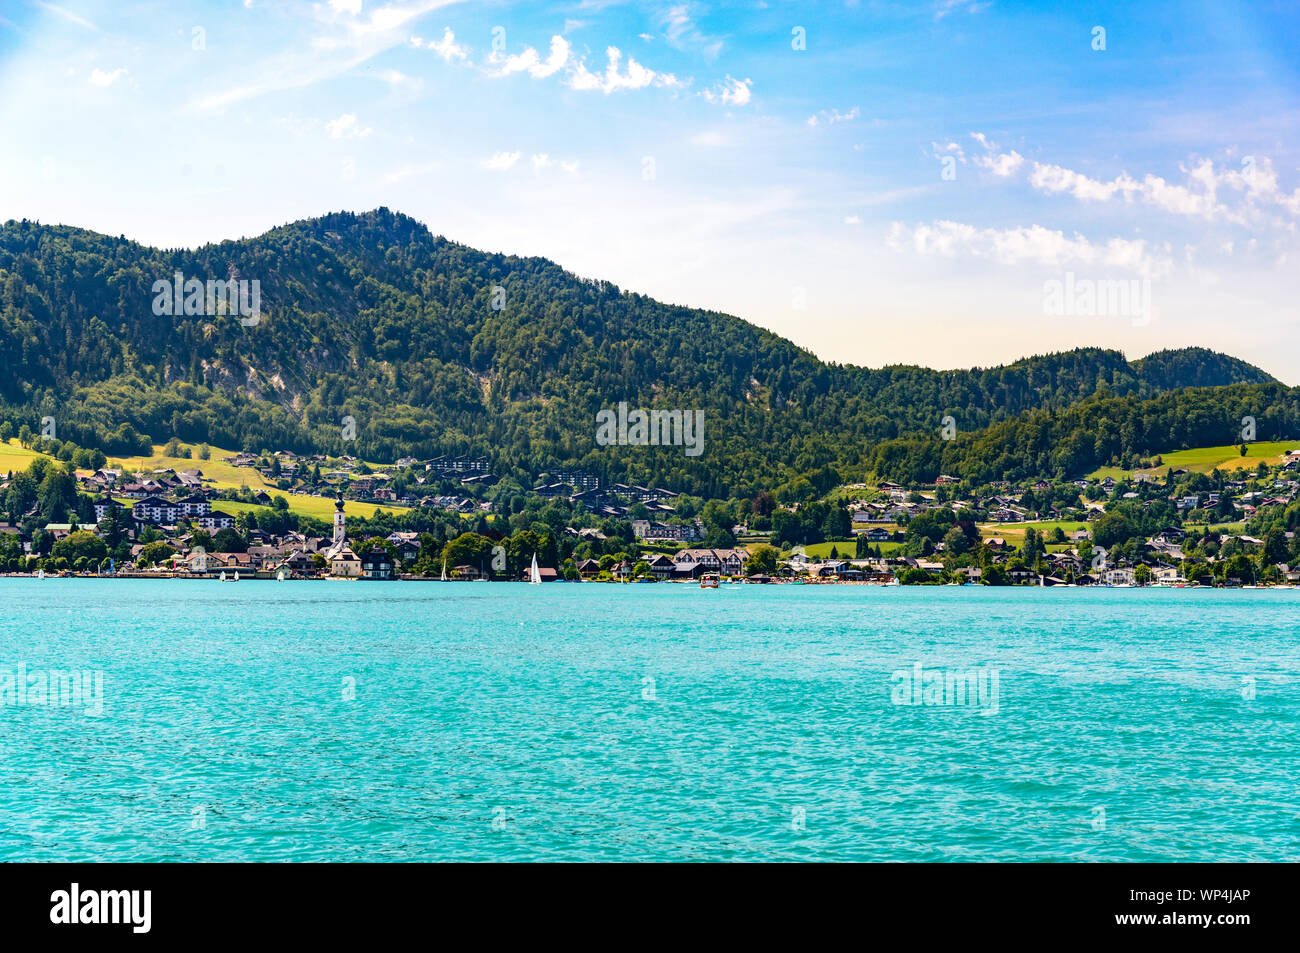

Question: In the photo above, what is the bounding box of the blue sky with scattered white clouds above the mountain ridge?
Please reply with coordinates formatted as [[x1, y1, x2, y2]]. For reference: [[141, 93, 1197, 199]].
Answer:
[[0, 0, 1300, 384]]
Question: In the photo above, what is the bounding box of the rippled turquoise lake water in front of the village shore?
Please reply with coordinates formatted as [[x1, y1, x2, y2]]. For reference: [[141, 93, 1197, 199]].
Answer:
[[0, 579, 1300, 861]]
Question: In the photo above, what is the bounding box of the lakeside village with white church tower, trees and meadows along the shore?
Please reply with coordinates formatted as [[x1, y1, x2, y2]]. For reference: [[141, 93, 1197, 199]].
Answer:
[[0, 439, 1300, 588]]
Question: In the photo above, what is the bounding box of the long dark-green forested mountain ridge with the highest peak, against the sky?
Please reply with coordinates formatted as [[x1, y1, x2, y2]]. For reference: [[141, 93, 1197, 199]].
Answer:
[[0, 208, 1275, 497]]
